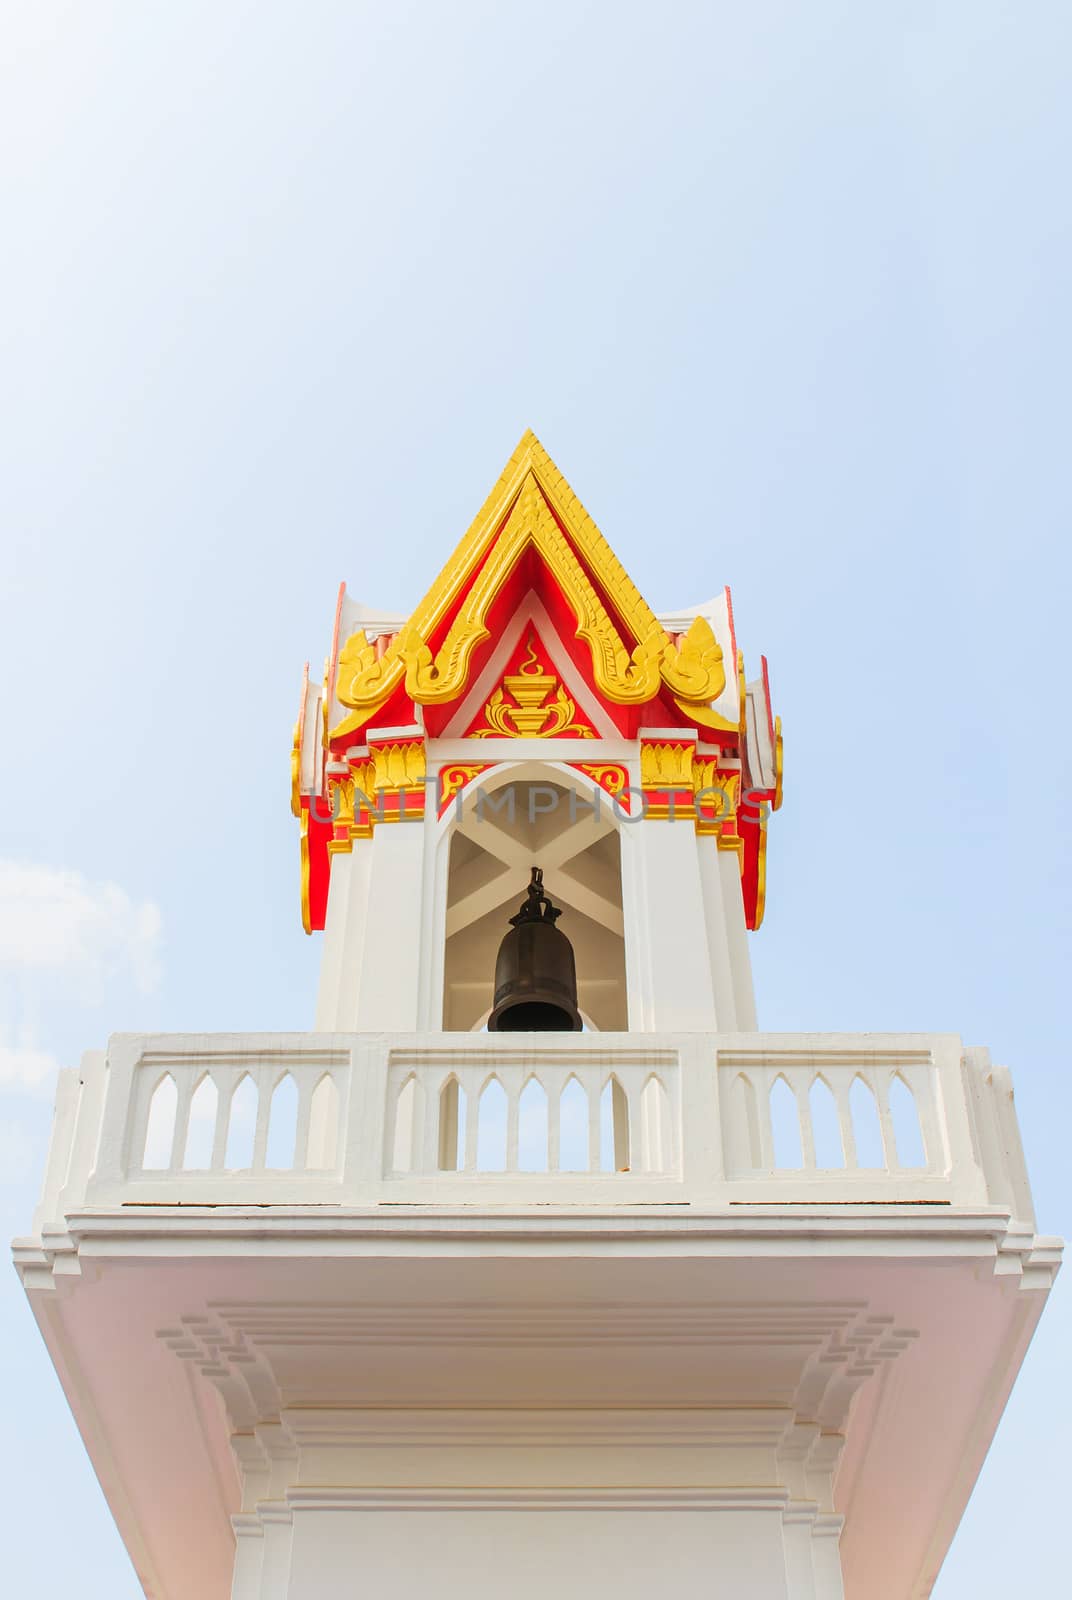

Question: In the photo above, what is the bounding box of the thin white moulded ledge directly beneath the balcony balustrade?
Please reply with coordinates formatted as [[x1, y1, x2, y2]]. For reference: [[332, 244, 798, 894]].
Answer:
[[13, 1205, 1062, 1293]]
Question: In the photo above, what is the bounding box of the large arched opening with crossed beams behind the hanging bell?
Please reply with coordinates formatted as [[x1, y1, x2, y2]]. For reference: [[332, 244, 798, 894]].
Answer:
[[443, 768, 629, 1032]]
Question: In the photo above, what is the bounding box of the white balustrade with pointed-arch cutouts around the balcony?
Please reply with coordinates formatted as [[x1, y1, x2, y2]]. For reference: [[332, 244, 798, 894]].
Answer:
[[38, 1034, 1030, 1226]]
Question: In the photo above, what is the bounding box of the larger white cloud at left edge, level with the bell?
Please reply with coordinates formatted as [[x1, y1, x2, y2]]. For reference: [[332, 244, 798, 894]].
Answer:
[[0, 861, 160, 998]]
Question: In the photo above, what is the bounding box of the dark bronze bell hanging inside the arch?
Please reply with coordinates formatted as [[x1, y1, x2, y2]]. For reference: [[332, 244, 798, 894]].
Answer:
[[488, 867, 582, 1034]]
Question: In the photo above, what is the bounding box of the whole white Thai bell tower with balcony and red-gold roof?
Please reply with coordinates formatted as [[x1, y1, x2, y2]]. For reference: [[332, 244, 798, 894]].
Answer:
[[14, 434, 1059, 1600]]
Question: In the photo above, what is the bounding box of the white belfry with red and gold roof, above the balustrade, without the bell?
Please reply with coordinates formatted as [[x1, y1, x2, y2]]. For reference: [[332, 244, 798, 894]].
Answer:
[[293, 434, 781, 1032]]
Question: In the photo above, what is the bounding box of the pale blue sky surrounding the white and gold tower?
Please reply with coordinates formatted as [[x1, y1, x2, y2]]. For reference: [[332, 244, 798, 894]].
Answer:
[[0, 0, 1072, 1600]]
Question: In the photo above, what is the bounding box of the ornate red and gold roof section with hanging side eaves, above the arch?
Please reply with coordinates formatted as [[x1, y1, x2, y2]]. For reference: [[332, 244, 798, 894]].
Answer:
[[291, 432, 781, 930]]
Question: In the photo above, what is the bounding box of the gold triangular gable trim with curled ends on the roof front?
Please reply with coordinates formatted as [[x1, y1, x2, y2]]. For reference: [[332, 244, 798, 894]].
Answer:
[[330, 430, 736, 742]]
